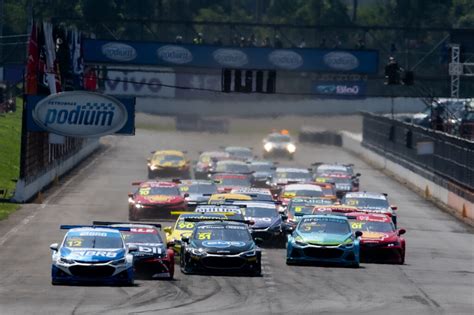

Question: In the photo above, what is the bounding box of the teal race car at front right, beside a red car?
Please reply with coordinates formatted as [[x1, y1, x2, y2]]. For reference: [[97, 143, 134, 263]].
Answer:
[[286, 215, 362, 267]]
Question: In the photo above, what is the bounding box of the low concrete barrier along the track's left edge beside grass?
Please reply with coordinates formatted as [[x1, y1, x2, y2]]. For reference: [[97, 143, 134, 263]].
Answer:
[[12, 139, 100, 202]]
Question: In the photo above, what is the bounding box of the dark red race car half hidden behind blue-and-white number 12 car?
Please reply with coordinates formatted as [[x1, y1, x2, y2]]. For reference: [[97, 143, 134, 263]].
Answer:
[[92, 221, 174, 280]]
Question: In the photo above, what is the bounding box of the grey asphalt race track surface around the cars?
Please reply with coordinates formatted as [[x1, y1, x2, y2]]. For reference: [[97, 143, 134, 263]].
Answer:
[[0, 130, 474, 314]]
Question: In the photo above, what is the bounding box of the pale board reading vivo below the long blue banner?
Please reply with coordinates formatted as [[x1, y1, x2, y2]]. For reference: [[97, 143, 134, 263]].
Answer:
[[104, 68, 176, 97]]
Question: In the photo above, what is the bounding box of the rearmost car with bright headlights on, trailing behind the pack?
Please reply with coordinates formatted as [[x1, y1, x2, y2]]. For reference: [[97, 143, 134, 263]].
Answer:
[[263, 130, 296, 160]]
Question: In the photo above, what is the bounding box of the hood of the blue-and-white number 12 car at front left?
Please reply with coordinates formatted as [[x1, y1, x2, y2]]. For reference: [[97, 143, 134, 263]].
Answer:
[[60, 247, 125, 263]]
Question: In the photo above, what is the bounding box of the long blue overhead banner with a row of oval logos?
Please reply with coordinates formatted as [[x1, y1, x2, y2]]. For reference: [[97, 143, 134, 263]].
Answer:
[[83, 39, 379, 74]]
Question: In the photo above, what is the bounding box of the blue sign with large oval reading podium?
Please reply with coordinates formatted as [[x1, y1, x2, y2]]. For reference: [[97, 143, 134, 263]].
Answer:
[[26, 91, 135, 137]]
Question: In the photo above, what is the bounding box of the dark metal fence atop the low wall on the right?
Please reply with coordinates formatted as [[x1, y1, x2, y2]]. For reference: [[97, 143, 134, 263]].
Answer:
[[363, 113, 474, 195]]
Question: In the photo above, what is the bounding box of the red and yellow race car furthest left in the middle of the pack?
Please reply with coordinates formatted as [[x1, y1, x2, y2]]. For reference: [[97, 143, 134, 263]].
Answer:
[[128, 181, 189, 221]]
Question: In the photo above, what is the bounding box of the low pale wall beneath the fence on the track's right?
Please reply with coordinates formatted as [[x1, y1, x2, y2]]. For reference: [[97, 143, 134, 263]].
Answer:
[[340, 131, 474, 226]]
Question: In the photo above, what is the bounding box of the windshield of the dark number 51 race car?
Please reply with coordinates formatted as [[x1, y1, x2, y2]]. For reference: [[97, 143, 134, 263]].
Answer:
[[193, 226, 252, 242]]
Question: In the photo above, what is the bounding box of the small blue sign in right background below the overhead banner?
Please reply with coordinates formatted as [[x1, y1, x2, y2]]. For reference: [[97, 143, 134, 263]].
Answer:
[[312, 81, 367, 97]]
